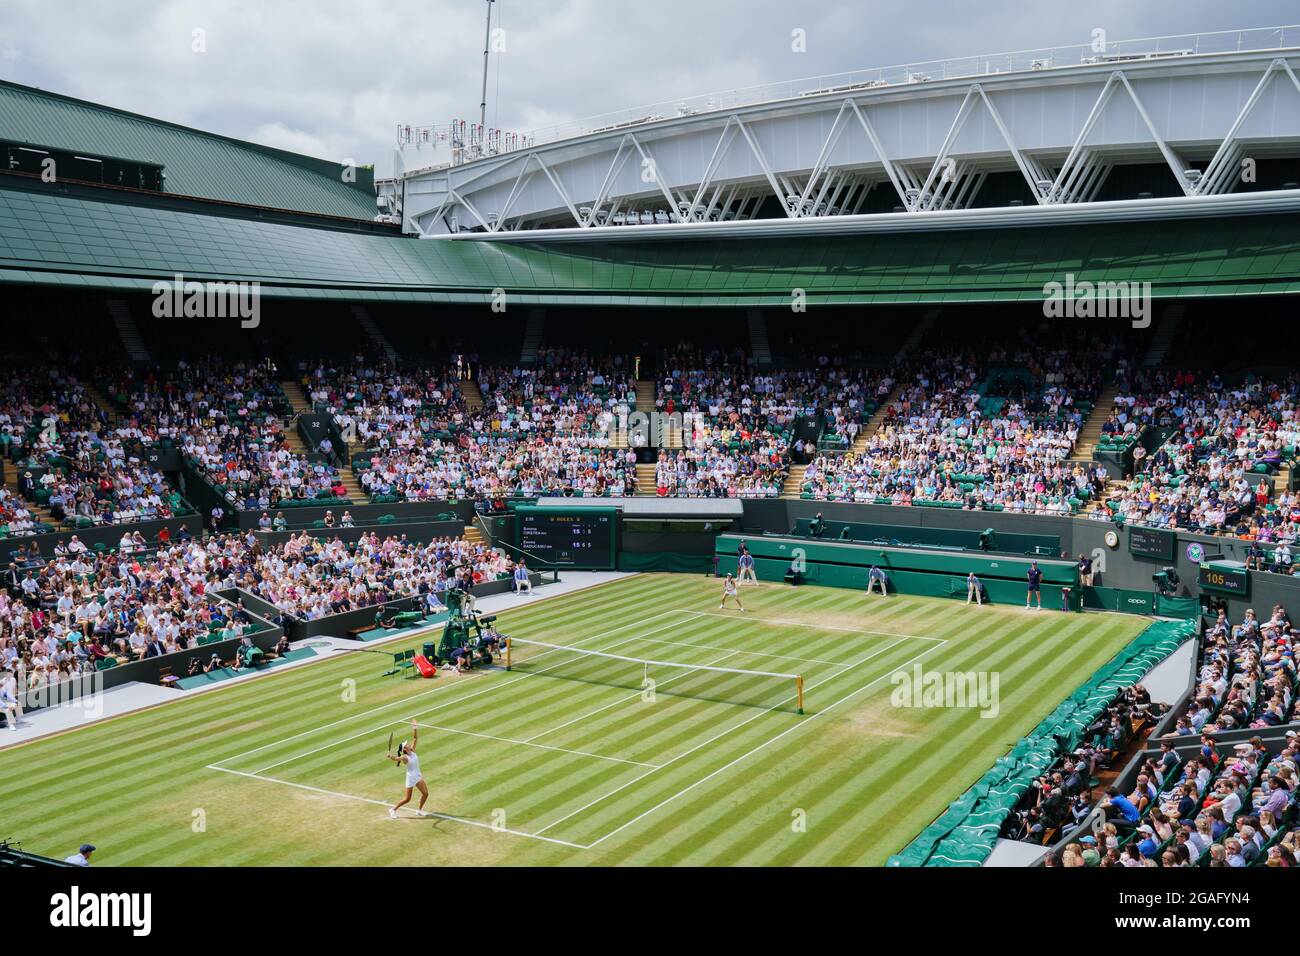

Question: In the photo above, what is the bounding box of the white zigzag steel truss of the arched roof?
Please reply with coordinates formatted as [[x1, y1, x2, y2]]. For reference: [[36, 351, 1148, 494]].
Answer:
[[403, 56, 1300, 235]]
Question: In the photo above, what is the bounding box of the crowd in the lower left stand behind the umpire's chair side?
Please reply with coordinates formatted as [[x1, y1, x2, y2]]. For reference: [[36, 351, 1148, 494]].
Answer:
[[0, 531, 514, 691]]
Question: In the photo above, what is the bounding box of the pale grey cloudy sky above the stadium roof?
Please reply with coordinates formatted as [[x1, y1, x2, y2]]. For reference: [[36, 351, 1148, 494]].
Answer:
[[0, 0, 1300, 174]]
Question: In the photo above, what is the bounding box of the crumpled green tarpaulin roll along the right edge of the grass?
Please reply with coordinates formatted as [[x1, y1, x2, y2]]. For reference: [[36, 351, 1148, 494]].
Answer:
[[887, 620, 1196, 866]]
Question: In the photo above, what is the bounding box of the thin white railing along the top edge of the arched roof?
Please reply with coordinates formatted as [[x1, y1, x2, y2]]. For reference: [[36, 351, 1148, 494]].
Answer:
[[423, 25, 1300, 161]]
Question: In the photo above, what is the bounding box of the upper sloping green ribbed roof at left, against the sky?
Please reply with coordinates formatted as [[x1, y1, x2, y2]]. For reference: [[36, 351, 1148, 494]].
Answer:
[[0, 81, 376, 220]]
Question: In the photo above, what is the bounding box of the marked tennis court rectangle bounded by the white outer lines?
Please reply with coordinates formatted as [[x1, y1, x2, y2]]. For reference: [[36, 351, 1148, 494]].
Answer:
[[212, 609, 945, 848]]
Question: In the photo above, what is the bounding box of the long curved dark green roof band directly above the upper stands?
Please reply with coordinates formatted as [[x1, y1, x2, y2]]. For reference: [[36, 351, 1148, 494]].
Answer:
[[0, 177, 1300, 307]]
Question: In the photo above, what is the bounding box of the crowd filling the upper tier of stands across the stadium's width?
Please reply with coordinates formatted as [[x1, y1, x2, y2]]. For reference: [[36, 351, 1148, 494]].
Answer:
[[0, 351, 1300, 546]]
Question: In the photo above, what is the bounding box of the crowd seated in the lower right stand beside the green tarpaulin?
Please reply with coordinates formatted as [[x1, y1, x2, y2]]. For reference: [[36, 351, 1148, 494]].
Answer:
[[1019, 606, 1300, 868]]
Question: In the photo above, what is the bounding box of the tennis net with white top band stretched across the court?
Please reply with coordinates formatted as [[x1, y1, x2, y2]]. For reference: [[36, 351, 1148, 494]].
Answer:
[[504, 637, 803, 714]]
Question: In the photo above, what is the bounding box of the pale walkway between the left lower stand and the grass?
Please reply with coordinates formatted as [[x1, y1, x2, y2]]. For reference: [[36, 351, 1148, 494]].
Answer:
[[0, 571, 633, 749]]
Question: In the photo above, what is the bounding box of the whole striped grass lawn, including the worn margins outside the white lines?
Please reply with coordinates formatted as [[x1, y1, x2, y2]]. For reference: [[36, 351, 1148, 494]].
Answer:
[[0, 575, 1148, 866]]
